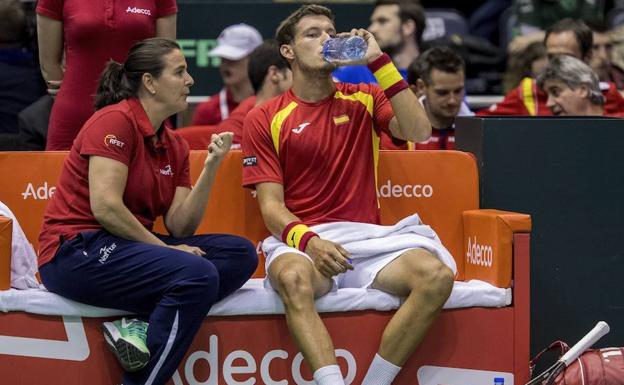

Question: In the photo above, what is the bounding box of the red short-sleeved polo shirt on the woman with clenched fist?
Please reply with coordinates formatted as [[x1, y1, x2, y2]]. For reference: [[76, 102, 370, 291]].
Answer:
[[39, 99, 191, 266]]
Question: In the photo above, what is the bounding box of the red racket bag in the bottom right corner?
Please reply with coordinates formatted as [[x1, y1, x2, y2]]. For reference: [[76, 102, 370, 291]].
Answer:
[[529, 341, 624, 385]]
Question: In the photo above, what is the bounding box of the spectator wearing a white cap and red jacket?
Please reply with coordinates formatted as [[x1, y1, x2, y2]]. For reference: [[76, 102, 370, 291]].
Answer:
[[193, 23, 262, 125]]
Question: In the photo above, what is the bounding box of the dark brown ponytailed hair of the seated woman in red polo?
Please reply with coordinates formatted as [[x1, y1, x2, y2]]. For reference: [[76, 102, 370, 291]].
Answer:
[[95, 37, 180, 110]]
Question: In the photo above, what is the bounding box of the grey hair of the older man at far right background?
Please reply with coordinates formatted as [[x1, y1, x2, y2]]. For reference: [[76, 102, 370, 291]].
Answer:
[[537, 55, 604, 105]]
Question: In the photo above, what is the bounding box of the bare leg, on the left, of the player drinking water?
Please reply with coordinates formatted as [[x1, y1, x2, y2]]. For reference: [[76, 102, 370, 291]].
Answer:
[[268, 254, 336, 372]]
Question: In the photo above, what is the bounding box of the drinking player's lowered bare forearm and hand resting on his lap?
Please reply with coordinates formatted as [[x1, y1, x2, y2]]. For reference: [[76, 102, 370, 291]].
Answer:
[[256, 182, 353, 278]]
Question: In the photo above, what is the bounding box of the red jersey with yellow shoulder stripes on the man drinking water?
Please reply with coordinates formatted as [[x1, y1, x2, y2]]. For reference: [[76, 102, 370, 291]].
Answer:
[[243, 83, 394, 225]]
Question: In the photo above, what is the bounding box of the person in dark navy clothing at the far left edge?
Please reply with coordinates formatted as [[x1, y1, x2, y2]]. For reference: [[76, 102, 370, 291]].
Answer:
[[0, 0, 45, 144]]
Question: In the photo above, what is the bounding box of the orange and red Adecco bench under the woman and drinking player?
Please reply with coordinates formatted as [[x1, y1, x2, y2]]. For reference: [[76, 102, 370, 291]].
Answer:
[[0, 151, 530, 385]]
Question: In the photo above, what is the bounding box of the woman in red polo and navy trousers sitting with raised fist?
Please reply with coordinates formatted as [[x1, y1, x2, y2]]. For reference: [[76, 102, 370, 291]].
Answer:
[[39, 38, 258, 385]]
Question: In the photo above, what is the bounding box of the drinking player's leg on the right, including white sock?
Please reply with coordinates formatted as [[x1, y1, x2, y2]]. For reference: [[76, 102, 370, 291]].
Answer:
[[362, 249, 454, 385]]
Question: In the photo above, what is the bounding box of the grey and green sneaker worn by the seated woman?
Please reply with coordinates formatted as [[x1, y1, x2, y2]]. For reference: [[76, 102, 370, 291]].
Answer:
[[102, 317, 150, 372]]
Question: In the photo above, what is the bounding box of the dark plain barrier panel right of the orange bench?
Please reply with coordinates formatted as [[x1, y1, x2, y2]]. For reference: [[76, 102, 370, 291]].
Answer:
[[456, 117, 624, 355]]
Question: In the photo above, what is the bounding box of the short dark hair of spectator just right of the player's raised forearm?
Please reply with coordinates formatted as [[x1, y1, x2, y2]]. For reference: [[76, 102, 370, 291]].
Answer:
[[407, 46, 465, 84]]
